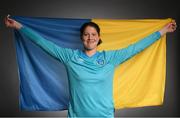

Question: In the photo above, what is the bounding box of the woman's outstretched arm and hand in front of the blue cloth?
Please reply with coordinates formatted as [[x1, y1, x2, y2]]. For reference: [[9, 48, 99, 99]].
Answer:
[[5, 16, 73, 63]]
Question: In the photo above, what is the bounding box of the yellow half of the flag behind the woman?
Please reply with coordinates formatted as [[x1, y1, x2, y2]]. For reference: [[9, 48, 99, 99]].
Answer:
[[92, 18, 172, 109]]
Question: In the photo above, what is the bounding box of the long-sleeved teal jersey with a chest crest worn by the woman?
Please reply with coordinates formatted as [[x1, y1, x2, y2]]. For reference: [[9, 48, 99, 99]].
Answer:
[[20, 27, 161, 118]]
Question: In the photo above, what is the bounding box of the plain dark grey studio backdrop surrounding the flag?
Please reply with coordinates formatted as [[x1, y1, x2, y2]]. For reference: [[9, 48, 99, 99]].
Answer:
[[0, 0, 180, 117]]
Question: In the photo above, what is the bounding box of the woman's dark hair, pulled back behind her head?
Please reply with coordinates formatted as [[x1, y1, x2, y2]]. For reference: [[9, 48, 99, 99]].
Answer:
[[80, 22, 102, 45]]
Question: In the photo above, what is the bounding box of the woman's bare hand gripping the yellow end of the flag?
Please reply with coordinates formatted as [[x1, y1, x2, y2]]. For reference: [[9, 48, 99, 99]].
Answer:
[[159, 20, 177, 36]]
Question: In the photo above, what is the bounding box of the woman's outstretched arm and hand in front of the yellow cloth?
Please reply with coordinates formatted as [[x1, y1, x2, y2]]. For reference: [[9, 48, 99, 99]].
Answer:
[[107, 21, 176, 65]]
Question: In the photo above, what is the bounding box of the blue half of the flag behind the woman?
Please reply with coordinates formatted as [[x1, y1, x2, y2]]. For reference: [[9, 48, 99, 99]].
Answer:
[[13, 16, 91, 111]]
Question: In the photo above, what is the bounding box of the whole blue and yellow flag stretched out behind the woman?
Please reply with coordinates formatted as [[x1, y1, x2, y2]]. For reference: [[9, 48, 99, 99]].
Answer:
[[14, 17, 171, 111]]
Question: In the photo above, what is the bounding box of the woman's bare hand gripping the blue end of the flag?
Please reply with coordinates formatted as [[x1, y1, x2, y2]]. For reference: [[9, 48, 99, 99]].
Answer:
[[4, 15, 22, 30]]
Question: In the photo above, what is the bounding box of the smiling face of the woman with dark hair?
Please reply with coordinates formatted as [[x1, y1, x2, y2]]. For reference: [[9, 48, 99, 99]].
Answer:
[[82, 26, 100, 50]]
